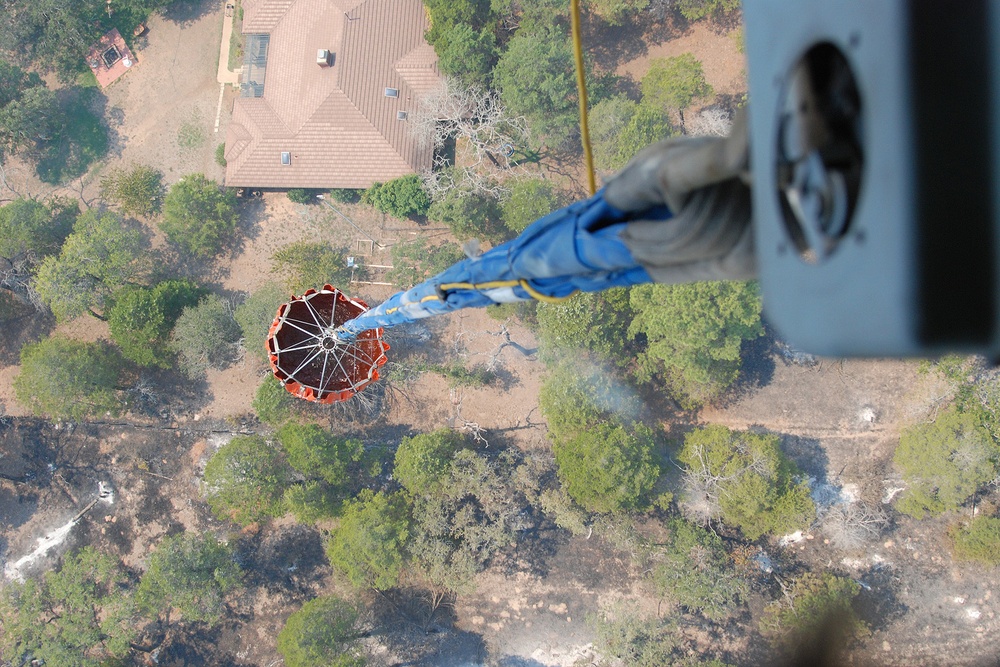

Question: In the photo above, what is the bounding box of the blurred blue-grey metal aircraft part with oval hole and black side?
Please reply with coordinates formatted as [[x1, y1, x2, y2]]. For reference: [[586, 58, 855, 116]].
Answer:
[[744, 0, 1000, 359]]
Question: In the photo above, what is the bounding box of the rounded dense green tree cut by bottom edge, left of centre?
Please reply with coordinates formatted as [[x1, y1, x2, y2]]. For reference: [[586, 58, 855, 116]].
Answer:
[[278, 595, 365, 667]]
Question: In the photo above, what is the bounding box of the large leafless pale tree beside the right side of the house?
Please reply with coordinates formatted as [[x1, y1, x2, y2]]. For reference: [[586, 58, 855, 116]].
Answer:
[[409, 79, 528, 199]]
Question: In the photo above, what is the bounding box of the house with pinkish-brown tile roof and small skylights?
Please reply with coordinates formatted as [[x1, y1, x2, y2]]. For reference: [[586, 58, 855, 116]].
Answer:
[[225, 0, 440, 189]]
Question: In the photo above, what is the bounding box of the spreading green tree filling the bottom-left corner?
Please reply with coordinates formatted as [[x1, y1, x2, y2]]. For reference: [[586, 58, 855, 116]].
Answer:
[[0, 547, 136, 667]]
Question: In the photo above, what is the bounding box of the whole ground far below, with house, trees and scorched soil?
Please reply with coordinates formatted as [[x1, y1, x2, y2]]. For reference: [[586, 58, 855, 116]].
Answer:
[[0, 0, 1000, 667]]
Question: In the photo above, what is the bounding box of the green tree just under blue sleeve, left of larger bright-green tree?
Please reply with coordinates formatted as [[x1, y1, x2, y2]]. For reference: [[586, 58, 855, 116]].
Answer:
[[535, 287, 632, 365]]
